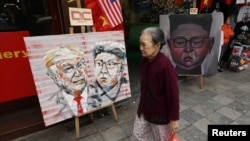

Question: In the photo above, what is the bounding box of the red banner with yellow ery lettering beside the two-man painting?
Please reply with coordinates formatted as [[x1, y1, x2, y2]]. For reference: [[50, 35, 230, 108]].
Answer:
[[0, 31, 36, 103]]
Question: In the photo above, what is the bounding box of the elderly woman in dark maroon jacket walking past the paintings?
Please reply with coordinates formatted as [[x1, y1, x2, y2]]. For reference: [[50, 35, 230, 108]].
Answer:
[[133, 27, 179, 141]]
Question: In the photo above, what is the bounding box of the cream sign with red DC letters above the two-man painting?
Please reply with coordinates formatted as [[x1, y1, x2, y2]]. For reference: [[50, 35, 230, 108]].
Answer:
[[69, 7, 93, 26]]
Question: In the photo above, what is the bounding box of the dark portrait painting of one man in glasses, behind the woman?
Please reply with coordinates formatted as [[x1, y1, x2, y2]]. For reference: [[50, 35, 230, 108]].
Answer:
[[160, 14, 223, 75]]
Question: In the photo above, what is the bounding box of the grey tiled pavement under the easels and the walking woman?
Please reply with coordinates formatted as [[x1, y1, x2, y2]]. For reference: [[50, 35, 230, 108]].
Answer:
[[13, 60, 250, 141]]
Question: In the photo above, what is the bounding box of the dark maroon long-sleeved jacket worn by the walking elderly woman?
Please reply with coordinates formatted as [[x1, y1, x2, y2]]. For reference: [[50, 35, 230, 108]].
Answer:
[[137, 52, 179, 124]]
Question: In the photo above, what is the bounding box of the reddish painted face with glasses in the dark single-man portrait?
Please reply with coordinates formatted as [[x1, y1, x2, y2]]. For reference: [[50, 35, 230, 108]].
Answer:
[[168, 24, 213, 70]]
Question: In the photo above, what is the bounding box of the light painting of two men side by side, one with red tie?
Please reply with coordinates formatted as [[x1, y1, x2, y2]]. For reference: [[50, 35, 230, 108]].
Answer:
[[24, 31, 131, 126]]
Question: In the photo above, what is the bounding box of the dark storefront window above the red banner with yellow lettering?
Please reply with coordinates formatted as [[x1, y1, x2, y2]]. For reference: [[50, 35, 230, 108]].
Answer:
[[0, 0, 52, 36]]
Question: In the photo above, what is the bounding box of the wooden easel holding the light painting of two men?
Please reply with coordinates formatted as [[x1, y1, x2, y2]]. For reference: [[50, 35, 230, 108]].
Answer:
[[69, 0, 118, 139]]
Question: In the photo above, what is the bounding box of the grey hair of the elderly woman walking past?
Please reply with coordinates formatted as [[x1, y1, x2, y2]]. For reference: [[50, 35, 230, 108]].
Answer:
[[141, 27, 166, 49]]
